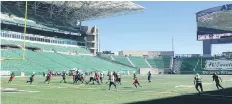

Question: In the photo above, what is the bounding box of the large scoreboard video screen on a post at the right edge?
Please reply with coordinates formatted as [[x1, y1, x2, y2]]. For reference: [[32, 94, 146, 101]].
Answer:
[[196, 4, 232, 40]]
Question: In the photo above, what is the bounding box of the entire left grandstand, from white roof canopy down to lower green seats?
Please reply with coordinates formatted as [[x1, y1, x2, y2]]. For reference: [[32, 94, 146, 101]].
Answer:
[[1, 1, 144, 75]]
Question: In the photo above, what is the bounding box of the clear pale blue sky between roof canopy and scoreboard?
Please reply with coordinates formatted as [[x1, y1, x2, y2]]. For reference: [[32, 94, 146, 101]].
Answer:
[[82, 1, 232, 54]]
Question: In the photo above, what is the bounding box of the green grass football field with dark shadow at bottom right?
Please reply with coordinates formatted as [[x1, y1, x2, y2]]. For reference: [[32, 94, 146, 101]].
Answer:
[[1, 75, 232, 104]]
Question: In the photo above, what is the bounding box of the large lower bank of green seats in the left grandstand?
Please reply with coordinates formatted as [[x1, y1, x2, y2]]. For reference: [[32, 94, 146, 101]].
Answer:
[[1, 46, 138, 75]]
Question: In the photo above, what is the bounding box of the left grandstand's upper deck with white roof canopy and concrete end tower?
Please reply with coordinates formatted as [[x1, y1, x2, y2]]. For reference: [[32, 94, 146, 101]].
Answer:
[[1, 1, 144, 53]]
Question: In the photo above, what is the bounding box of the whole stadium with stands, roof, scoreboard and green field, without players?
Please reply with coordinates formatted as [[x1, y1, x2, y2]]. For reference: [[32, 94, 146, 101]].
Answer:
[[1, 1, 232, 104]]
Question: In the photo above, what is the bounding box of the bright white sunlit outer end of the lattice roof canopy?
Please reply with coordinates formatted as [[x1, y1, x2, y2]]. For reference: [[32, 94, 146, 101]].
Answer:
[[41, 1, 144, 21]]
